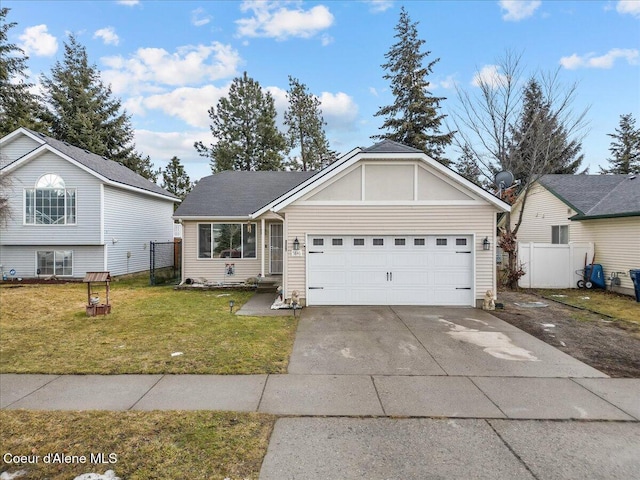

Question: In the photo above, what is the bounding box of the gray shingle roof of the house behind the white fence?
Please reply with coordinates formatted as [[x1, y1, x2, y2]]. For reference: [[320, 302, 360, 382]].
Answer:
[[539, 175, 640, 220]]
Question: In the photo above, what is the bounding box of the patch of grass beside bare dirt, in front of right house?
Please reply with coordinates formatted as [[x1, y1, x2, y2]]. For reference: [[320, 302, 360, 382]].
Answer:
[[537, 289, 640, 327]]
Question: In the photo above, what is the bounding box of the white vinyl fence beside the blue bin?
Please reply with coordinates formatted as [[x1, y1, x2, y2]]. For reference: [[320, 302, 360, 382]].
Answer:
[[518, 242, 594, 288]]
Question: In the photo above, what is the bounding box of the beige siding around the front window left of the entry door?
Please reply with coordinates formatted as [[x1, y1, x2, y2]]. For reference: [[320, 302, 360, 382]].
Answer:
[[182, 220, 269, 282]]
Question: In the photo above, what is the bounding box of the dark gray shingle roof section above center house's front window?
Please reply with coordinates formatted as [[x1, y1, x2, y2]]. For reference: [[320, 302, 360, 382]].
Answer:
[[174, 171, 316, 217]]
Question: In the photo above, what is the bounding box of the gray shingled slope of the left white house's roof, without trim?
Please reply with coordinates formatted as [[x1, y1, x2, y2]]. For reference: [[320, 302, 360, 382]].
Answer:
[[16, 128, 177, 199]]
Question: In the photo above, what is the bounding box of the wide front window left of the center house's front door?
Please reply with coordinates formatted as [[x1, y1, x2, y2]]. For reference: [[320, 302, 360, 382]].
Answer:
[[198, 223, 257, 258]]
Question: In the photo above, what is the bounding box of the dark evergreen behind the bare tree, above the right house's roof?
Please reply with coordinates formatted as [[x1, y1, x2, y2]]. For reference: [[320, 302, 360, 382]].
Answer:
[[507, 78, 584, 185]]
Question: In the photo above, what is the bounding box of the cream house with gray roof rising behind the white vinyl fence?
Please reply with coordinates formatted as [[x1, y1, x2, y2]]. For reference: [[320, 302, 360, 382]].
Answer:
[[511, 175, 640, 295]]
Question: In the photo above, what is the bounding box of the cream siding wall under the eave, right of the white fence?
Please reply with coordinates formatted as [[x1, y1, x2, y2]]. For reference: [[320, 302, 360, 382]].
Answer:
[[571, 217, 640, 294]]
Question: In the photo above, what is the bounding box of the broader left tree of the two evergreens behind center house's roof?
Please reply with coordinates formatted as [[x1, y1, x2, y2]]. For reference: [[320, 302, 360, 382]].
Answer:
[[194, 72, 286, 173]]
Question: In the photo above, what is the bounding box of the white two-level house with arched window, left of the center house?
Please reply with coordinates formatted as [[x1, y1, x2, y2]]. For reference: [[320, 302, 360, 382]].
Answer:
[[0, 128, 179, 278]]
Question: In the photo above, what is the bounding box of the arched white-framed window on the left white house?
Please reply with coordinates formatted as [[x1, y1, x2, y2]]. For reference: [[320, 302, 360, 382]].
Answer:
[[24, 173, 76, 225]]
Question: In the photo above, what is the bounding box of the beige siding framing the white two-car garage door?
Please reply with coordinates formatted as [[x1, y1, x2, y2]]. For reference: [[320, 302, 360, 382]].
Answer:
[[284, 202, 496, 299]]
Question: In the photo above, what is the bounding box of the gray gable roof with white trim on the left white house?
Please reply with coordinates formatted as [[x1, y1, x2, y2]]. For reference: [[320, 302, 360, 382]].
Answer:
[[3, 127, 179, 201]]
